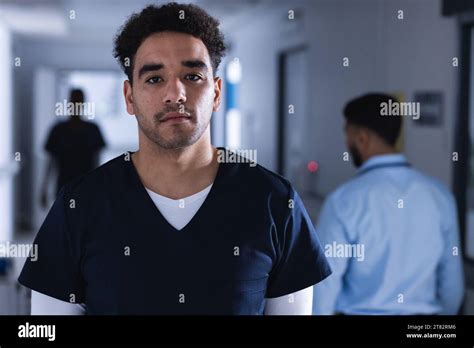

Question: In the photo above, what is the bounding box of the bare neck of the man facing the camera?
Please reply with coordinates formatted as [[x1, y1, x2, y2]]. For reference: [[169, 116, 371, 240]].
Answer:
[[132, 136, 219, 199]]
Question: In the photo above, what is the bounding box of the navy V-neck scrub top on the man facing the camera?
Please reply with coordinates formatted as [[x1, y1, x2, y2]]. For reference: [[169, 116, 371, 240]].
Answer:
[[18, 149, 331, 315]]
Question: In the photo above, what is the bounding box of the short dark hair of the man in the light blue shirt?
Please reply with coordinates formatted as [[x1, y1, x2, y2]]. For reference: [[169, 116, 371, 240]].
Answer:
[[344, 93, 402, 146]]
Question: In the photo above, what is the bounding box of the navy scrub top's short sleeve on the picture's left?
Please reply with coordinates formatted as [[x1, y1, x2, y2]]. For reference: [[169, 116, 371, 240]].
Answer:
[[18, 188, 84, 303]]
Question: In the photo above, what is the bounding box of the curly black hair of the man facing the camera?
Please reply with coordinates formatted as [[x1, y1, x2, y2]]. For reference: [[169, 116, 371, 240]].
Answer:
[[114, 2, 226, 82]]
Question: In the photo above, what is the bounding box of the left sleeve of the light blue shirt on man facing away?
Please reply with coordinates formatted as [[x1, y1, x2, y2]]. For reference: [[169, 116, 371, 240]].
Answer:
[[313, 196, 351, 315]]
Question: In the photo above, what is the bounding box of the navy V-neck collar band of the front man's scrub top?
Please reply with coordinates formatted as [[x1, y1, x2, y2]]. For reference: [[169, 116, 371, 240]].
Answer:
[[125, 147, 227, 233]]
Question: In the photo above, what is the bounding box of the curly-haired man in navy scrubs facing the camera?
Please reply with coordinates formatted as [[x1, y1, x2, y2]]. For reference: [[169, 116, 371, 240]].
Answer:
[[19, 3, 331, 314]]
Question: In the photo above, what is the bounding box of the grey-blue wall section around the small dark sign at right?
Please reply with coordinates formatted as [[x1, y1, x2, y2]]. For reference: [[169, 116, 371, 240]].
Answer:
[[383, 0, 460, 187]]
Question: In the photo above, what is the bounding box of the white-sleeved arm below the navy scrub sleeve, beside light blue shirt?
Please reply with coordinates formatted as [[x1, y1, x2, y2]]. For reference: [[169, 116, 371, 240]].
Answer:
[[264, 286, 313, 315]]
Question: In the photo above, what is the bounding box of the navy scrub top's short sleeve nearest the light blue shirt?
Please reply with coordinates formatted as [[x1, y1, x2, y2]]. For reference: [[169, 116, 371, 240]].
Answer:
[[266, 189, 331, 298]]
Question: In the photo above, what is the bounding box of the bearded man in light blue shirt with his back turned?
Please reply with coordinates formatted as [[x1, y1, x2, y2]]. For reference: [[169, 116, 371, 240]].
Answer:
[[313, 94, 464, 314]]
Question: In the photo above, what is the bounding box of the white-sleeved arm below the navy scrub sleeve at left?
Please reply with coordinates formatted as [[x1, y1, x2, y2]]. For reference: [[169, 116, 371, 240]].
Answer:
[[31, 290, 85, 315]]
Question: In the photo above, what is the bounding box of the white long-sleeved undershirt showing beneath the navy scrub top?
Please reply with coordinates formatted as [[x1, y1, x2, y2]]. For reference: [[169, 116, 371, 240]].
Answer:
[[31, 184, 313, 315]]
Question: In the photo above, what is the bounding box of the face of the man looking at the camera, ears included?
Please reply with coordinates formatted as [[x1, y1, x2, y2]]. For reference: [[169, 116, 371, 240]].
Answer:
[[124, 32, 221, 149]]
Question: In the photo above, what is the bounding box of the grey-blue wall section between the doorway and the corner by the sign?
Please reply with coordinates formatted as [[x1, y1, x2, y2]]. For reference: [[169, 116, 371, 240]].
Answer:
[[306, 0, 384, 195]]
